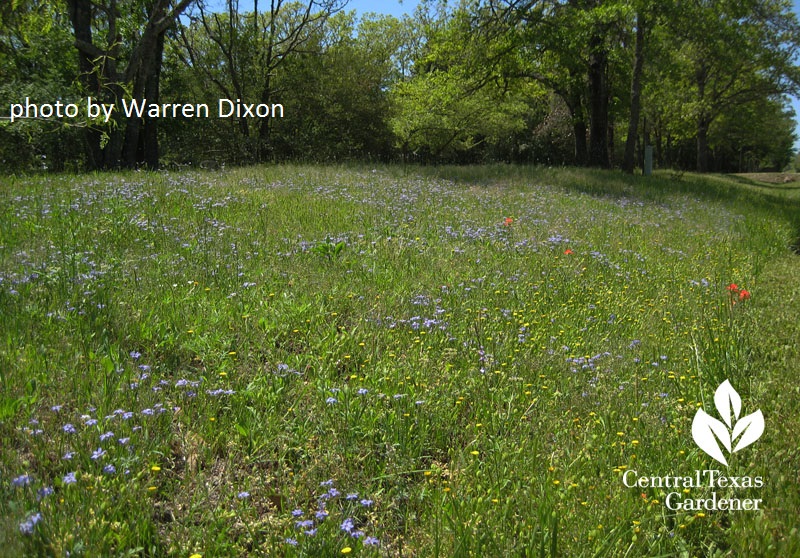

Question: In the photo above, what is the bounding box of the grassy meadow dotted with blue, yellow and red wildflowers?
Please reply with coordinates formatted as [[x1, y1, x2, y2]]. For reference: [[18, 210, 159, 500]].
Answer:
[[0, 166, 800, 558]]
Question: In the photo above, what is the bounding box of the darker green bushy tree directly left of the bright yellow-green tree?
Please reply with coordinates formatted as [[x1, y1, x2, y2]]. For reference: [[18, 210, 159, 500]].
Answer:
[[271, 12, 400, 161]]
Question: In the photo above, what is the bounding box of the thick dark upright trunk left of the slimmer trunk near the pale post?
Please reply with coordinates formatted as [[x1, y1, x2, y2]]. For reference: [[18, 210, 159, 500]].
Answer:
[[589, 33, 609, 168]]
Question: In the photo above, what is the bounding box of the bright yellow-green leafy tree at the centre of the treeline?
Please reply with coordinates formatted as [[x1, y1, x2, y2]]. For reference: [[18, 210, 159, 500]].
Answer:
[[391, 5, 543, 161]]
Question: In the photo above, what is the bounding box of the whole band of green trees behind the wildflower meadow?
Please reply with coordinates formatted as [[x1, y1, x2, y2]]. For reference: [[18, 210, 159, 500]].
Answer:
[[0, 0, 800, 171]]
